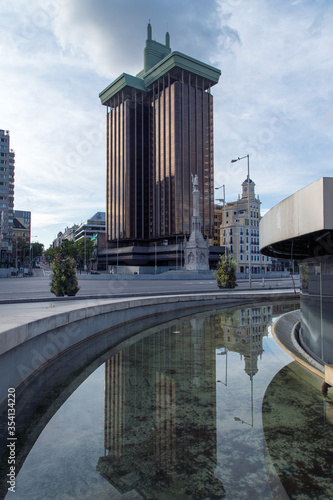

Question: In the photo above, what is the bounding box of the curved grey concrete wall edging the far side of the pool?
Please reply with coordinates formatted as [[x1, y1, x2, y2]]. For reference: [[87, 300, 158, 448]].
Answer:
[[0, 292, 296, 404]]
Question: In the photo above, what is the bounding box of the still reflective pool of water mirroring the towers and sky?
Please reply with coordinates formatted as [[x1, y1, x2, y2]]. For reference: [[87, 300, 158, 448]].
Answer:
[[1, 304, 333, 500]]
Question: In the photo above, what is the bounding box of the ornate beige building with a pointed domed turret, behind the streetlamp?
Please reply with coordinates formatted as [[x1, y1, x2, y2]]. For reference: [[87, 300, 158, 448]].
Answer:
[[213, 178, 273, 274]]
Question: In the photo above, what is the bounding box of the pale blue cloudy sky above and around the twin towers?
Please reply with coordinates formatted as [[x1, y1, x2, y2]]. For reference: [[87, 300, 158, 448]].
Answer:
[[0, 0, 333, 248]]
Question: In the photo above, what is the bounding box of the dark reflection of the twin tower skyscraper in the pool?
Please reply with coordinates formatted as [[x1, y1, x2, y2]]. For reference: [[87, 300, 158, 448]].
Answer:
[[97, 317, 225, 499]]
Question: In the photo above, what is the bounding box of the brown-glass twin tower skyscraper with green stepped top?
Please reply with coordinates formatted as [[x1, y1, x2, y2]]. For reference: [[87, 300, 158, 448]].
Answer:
[[100, 23, 221, 250]]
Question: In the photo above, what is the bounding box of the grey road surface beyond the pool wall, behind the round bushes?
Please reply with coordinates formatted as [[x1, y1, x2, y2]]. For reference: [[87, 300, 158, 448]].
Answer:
[[0, 268, 299, 302]]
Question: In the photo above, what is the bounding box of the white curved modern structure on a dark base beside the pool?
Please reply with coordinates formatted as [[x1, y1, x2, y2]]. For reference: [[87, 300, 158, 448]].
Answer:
[[260, 177, 333, 385]]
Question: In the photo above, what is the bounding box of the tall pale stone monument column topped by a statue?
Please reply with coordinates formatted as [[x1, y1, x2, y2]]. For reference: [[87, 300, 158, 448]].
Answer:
[[184, 174, 209, 272]]
